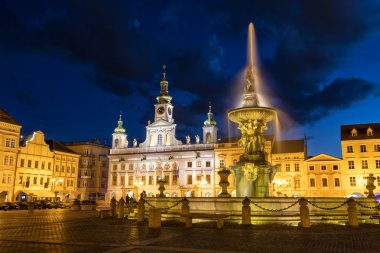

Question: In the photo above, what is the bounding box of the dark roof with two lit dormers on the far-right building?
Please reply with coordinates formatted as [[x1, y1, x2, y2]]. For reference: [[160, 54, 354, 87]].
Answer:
[[340, 123, 380, 141]]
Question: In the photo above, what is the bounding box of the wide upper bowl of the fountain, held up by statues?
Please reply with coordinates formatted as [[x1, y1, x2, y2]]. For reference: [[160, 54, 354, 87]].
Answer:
[[228, 107, 277, 124]]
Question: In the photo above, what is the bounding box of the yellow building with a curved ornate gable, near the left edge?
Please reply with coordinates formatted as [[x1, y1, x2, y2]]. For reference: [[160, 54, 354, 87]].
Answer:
[[14, 131, 54, 201]]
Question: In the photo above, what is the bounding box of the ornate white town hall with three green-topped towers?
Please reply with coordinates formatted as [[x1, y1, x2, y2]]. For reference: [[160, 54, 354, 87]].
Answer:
[[107, 67, 219, 199]]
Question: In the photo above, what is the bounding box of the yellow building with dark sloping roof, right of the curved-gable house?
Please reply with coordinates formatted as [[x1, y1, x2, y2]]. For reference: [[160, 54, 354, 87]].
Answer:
[[46, 140, 80, 201]]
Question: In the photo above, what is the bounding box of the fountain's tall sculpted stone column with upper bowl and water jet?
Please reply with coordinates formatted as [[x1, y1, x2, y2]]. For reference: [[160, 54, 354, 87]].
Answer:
[[228, 23, 277, 197]]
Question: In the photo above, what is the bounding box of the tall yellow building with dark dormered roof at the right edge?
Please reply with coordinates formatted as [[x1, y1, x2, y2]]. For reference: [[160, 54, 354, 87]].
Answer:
[[341, 123, 380, 196]]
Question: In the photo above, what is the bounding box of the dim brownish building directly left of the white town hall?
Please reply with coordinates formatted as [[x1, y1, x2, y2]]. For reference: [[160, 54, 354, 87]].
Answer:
[[65, 140, 110, 200]]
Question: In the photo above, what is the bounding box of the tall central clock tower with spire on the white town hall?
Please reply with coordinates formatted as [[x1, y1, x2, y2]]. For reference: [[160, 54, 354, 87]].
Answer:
[[154, 65, 174, 123]]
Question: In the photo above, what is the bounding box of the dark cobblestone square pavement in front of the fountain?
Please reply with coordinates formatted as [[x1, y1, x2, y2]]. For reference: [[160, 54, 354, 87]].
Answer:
[[0, 209, 380, 253]]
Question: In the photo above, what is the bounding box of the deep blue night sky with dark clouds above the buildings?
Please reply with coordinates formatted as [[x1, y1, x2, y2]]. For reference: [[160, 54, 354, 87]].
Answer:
[[0, 0, 380, 157]]
